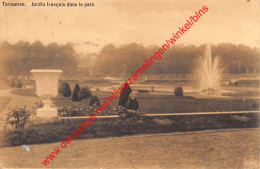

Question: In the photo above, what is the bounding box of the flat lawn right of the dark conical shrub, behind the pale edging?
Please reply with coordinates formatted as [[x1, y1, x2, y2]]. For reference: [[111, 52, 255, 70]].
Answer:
[[137, 94, 259, 113]]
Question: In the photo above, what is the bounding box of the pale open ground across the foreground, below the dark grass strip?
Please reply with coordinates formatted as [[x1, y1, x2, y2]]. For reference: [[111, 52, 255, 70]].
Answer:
[[0, 129, 260, 169]]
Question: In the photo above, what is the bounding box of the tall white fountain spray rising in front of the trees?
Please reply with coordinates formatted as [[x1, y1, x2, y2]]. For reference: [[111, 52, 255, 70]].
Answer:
[[199, 44, 223, 94]]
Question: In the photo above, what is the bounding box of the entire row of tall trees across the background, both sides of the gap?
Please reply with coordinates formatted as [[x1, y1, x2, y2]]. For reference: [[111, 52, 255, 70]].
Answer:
[[0, 41, 259, 76]]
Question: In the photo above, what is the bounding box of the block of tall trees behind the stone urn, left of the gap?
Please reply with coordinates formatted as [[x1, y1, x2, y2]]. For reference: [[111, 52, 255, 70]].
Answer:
[[0, 41, 78, 76]]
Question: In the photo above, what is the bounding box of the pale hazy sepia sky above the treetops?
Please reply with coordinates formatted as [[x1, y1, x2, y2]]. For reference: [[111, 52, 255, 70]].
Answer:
[[0, 0, 260, 53]]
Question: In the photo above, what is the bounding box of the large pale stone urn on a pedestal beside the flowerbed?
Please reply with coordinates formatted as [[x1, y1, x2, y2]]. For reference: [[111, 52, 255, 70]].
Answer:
[[31, 69, 62, 118]]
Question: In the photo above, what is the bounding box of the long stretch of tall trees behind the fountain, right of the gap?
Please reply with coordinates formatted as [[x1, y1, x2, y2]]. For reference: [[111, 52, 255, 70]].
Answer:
[[95, 43, 259, 75]]
